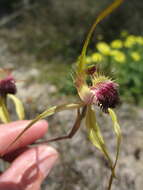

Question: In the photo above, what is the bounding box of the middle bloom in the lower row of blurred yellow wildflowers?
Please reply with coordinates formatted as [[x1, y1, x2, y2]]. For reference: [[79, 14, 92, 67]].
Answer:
[[110, 50, 126, 63]]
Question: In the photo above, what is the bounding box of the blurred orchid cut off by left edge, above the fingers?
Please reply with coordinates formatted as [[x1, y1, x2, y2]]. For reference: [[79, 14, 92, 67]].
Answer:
[[0, 69, 24, 123]]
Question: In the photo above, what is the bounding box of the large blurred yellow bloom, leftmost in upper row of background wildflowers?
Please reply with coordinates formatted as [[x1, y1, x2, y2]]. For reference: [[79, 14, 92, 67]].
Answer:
[[96, 42, 111, 55]]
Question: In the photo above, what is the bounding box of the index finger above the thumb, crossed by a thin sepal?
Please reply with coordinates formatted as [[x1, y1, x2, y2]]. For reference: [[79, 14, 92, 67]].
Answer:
[[0, 120, 48, 155]]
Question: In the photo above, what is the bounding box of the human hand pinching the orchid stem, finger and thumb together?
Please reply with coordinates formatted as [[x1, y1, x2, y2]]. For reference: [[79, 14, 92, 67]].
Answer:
[[0, 120, 58, 190]]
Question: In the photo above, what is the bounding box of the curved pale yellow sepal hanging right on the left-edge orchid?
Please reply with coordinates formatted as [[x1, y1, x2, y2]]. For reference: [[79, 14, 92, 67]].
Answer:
[[8, 94, 25, 120]]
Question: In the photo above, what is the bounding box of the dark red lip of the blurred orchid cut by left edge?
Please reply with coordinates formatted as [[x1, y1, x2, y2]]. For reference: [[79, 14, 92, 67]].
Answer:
[[0, 76, 16, 96]]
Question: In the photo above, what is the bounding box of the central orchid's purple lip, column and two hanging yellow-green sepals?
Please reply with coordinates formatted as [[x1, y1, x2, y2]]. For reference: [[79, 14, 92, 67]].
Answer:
[[75, 66, 121, 169]]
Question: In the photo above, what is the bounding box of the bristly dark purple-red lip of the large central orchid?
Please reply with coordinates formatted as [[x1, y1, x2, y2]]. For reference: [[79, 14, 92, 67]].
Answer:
[[91, 81, 119, 112]]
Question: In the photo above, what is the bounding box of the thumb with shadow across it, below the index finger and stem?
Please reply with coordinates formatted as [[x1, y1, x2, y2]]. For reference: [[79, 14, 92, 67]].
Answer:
[[0, 145, 58, 190]]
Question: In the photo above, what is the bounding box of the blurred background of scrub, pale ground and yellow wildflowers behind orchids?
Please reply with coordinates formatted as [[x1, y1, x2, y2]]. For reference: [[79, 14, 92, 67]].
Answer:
[[0, 0, 143, 190]]
